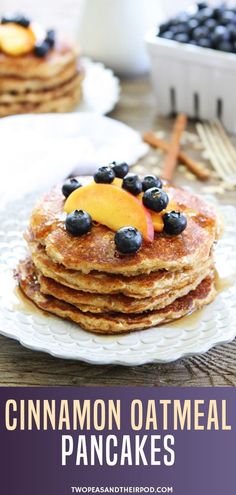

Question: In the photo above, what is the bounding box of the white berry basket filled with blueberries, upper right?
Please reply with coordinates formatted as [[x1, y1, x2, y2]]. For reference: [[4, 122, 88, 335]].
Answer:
[[146, 2, 236, 133]]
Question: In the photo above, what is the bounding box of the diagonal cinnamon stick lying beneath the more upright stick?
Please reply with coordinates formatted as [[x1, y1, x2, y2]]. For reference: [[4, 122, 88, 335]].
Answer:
[[143, 131, 210, 181]]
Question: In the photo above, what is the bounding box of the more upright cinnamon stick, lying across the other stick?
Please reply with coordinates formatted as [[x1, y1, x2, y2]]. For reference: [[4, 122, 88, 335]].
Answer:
[[162, 113, 187, 181]]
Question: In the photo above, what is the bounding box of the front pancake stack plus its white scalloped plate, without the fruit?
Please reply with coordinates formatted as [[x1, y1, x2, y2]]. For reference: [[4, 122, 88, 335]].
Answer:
[[0, 181, 236, 365]]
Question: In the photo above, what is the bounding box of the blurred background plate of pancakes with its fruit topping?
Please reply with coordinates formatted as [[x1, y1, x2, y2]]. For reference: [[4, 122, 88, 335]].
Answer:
[[0, 13, 119, 117]]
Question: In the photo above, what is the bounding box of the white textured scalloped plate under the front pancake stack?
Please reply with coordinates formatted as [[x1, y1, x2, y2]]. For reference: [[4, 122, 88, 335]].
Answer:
[[0, 195, 236, 365]]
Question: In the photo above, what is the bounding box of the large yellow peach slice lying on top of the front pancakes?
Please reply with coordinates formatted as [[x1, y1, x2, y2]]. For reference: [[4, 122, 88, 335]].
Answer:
[[64, 182, 154, 242]]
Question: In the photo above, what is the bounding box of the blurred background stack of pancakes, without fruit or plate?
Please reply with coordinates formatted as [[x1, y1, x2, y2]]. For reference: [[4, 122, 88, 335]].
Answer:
[[0, 40, 83, 117]]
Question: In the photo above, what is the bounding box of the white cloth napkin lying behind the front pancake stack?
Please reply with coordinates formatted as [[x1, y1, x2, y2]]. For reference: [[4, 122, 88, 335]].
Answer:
[[0, 113, 148, 206]]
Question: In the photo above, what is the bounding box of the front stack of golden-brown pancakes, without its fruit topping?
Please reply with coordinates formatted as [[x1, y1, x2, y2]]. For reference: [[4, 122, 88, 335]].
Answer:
[[18, 179, 219, 334]]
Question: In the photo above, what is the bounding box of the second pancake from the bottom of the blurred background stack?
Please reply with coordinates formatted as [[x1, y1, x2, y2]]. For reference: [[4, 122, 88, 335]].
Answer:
[[0, 73, 83, 107]]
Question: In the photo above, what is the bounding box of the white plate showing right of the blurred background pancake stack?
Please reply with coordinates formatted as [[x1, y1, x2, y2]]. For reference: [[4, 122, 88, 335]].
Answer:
[[79, 58, 120, 115]]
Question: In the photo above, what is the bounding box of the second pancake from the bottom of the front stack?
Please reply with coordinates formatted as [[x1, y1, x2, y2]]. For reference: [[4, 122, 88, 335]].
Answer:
[[37, 267, 213, 314]]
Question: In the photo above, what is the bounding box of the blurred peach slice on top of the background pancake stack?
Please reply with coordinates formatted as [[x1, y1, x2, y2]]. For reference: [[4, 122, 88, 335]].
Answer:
[[0, 23, 35, 56]]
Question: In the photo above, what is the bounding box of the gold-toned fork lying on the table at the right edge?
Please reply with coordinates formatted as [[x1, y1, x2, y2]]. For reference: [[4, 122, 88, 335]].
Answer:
[[196, 120, 236, 186]]
